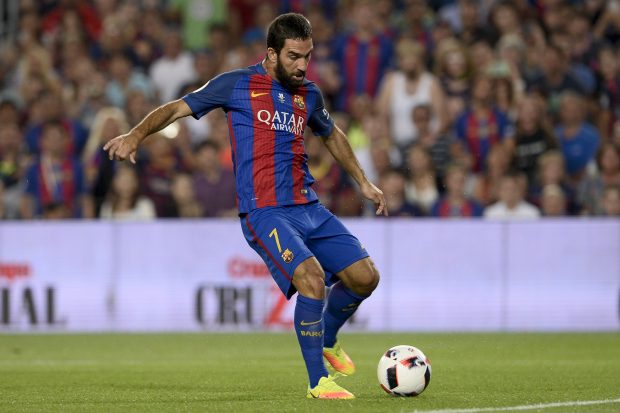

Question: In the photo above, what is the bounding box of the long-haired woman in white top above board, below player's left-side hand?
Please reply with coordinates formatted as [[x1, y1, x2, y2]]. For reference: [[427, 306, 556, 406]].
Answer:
[[99, 165, 157, 221]]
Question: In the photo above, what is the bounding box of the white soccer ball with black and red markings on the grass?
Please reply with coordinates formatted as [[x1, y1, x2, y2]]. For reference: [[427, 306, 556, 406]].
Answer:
[[377, 345, 431, 396]]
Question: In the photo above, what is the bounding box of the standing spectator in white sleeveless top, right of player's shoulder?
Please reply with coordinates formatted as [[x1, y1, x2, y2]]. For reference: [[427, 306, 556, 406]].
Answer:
[[376, 38, 448, 150]]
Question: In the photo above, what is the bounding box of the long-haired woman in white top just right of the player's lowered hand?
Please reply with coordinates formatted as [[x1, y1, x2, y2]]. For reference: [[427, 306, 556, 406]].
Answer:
[[405, 144, 439, 215]]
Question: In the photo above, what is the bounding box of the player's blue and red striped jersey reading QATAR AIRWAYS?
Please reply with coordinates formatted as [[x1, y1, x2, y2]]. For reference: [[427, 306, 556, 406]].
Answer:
[[183, 63, 334, 213]]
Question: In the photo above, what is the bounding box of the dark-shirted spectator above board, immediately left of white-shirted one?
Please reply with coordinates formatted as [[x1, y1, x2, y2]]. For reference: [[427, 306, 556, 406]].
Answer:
[[431, 164, 482, 218]]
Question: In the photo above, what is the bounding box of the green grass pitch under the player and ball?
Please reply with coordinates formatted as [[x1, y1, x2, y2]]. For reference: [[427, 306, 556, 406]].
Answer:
[[0, 333, 620, 413]]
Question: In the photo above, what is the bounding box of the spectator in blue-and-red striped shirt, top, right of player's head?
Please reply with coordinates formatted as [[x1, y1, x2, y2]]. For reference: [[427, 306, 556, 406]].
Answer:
[[334, 0, 394, 110]]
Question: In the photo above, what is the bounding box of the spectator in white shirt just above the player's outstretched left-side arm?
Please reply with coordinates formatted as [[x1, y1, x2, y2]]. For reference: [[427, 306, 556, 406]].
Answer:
[[149, 30, 196, 102]]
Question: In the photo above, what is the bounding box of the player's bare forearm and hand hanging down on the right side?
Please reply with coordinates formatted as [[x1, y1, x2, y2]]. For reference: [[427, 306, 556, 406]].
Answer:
[[323, 125, 388, 216]]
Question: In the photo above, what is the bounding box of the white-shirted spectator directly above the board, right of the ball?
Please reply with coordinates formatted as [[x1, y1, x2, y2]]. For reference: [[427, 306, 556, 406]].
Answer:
[[484, 174, 540, 219]]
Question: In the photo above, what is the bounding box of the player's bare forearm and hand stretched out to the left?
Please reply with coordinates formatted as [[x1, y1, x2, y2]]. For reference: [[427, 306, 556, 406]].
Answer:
[[103, 99, 192, 163]]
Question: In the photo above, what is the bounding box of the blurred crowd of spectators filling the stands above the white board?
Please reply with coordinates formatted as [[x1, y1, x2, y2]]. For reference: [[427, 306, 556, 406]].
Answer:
[[0, 0, 620, 219]]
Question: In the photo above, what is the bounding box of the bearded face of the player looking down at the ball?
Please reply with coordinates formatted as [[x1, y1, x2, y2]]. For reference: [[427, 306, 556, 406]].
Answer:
[[276, 39, 313, 90]]
